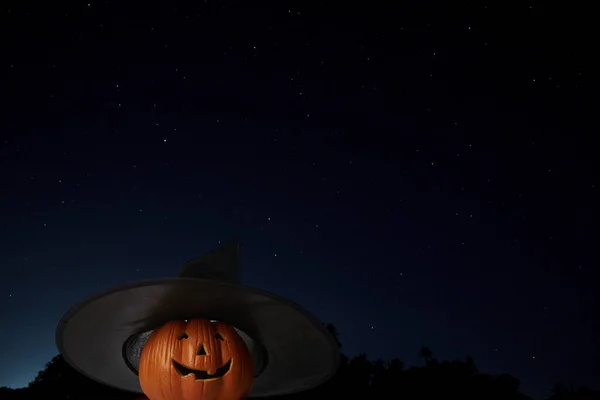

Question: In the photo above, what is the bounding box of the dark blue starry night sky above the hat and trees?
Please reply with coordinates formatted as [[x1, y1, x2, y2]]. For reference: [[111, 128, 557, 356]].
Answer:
[[0, 0, 600, 398]]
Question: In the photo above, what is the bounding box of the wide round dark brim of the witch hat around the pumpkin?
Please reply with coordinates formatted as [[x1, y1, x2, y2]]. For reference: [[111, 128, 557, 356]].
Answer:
[[56, 278, 339, 397]]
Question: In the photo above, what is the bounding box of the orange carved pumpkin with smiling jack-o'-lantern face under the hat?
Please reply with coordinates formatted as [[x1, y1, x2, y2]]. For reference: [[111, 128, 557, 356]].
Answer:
[[138, 319, 254, 400]]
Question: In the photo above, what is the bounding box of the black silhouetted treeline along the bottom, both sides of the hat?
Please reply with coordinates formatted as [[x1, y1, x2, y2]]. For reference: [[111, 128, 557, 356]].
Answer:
[[0, 325, 600, 400]]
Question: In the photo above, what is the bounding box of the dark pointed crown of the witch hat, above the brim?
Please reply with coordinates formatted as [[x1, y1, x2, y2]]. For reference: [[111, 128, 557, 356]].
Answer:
[[178, 238, 241, 283]]
